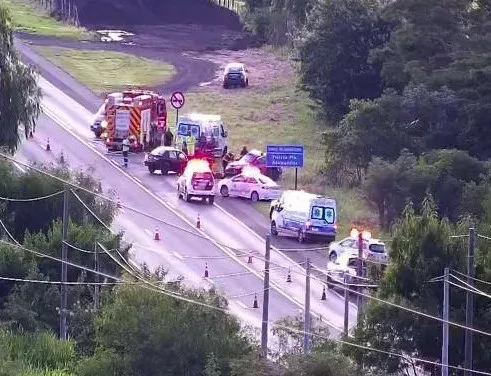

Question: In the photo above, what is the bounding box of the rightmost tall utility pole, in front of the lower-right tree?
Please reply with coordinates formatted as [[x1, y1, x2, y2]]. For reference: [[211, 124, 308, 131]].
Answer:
[[464, 227, 476, 376]]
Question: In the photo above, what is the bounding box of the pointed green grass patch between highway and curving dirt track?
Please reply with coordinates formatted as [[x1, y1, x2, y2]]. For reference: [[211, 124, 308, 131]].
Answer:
[[33, 46, 176, 95]]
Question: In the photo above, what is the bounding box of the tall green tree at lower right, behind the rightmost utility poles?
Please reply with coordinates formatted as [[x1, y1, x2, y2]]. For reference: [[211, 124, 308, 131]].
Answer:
[[345, 196, 491, 374]]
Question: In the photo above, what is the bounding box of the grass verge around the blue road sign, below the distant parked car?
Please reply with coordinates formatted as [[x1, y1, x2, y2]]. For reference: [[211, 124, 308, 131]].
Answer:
[[185, 82, 378, 237]]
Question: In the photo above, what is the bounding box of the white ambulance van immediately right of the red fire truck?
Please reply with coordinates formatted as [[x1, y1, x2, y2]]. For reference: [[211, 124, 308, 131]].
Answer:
[[177, 113, 228, 158]]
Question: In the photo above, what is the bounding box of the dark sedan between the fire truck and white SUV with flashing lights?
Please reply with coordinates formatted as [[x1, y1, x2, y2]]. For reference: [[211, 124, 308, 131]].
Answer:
[[144, 146, 188, 175]]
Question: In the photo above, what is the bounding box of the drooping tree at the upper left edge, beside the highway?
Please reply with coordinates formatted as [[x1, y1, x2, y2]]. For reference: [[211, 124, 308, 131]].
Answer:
[[0, 5, 41, 152]]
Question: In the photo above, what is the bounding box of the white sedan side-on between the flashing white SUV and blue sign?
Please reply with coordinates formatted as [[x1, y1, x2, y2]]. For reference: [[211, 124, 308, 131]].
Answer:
[[219, 173, 281, 202]]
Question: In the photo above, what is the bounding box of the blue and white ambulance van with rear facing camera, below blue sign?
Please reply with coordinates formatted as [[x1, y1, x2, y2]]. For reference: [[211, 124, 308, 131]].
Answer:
[[269, 190, 337, 243]]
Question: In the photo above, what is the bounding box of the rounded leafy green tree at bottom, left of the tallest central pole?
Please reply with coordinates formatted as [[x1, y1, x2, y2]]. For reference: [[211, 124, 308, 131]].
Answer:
[[82, 285, 251, 376]]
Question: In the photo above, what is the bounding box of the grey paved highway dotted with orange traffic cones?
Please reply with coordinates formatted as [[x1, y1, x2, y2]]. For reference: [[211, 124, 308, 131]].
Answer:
[[12, 40, 356, 334]]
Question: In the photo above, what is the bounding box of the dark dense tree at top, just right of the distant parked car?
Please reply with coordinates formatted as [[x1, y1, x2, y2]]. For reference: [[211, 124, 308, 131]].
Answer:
[[296, 0, 390, 119]]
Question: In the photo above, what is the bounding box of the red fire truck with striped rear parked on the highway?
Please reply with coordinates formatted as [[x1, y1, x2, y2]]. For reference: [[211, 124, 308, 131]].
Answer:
[[100, 90, 167, 152]]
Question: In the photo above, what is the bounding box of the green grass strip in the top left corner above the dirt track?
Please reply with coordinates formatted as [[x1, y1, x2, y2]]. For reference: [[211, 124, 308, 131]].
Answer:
[[1, 0, 94, 40]]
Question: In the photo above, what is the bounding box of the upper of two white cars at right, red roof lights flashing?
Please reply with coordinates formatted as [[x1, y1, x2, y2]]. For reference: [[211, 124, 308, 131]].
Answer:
[[329, 237, 389, 264]]
